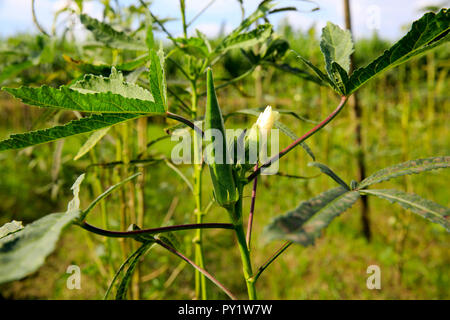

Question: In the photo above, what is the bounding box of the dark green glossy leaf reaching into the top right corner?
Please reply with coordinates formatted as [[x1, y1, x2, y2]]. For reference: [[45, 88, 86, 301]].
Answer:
[[348, 9, 450, 94]]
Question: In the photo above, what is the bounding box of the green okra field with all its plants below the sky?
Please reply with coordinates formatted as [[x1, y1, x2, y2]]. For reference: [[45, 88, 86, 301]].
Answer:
[[0, 0, 450, 300]]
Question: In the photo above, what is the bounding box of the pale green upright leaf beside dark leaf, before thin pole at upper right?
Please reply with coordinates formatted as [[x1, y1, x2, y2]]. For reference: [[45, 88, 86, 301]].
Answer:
[[320, 22, 353, 79]]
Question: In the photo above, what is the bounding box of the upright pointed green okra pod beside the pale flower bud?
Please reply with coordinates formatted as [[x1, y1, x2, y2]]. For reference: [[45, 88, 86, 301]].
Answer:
[[205, 68, 239, 209]]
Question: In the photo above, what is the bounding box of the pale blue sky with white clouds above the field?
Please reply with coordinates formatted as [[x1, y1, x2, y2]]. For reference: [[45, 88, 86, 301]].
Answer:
[[0, 0, 450, 40]]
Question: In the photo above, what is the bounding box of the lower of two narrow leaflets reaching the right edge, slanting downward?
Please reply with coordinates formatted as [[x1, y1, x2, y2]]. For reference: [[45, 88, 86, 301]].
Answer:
[[360, 189, 450, 232]]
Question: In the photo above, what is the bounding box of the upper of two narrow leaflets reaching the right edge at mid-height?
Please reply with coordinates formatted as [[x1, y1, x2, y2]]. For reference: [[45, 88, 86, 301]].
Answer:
[[358, 156, 450, 189]]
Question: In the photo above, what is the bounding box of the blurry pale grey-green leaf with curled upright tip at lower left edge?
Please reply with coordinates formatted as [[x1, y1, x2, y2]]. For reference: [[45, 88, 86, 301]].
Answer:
[[0, 175, 84, 284]]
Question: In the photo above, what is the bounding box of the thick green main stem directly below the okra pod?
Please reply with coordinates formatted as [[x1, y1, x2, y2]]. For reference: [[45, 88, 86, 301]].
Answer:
[[229, 186, 257, 300]]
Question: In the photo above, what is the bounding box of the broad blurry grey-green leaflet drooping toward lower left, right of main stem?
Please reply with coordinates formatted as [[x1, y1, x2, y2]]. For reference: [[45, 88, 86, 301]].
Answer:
[[264, 187, 359, 246]]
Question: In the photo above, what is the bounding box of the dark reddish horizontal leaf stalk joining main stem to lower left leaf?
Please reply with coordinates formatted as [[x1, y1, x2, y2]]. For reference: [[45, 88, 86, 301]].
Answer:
[[79, 221, 234, 238]]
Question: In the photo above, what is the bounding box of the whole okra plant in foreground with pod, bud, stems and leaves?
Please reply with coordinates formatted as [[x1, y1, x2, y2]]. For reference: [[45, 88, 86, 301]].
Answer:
[[0, 1, 450, 299]]
